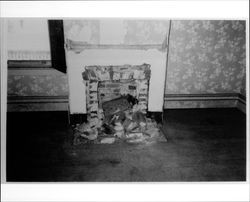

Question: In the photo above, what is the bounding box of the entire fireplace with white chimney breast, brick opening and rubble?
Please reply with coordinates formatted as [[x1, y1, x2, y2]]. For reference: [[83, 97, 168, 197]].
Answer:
[[64, 19, 168, 142]]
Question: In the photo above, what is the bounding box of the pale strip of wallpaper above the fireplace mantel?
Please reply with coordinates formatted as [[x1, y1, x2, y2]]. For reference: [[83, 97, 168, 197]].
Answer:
[[64, 19, 169, 45]]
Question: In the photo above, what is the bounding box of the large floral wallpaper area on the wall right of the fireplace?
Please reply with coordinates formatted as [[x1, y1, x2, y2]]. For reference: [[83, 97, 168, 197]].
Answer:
[[166, 20, 246, 94]]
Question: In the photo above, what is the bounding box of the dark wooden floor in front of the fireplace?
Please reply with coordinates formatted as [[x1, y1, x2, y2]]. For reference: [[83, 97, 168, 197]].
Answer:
[[7, 109, 246, 182]]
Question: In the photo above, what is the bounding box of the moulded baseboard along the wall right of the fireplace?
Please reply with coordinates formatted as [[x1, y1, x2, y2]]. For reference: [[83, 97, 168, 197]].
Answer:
[[164, 93, 244, 112]]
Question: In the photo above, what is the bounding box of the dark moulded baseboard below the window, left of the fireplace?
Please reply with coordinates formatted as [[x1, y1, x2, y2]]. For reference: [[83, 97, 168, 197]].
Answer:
[[7, 96, 69, 112]]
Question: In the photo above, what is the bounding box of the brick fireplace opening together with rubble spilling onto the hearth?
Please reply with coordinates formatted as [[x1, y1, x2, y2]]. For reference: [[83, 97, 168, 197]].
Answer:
[[74, 64, 166, 144]]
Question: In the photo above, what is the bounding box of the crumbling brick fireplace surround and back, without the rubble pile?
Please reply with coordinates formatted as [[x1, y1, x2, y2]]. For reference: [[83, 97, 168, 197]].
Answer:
[[82, 64, 150, 126]]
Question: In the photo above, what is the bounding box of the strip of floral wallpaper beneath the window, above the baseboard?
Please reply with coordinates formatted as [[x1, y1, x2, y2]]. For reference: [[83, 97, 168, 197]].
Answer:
[[8, 75, 68, 96]]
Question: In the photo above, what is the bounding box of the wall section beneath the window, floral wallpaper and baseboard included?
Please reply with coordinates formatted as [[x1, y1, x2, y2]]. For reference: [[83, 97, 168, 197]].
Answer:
[[7, 69, 69, 111]]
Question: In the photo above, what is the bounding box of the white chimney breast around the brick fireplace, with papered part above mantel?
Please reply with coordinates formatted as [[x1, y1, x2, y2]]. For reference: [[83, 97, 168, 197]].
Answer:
[[64, 19, 169, 113]]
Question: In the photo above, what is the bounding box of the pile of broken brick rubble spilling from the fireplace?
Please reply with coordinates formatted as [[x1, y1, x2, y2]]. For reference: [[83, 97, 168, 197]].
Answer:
[[74, 95, 166, 145]]
